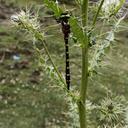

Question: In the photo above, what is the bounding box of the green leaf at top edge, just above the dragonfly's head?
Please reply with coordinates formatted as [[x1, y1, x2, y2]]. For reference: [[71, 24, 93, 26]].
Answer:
[[44, 0, 63, 17]]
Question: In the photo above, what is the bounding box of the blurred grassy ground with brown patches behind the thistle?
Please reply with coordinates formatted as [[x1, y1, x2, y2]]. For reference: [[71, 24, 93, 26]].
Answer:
[[0, 0, 128, 128]]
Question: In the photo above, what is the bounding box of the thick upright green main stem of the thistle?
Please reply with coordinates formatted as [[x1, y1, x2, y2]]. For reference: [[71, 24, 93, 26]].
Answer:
[[78, 0, 88, 128]]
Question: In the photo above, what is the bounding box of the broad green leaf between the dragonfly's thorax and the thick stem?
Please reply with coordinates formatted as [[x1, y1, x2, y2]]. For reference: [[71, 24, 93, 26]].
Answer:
[[69, 17, 86, 45]]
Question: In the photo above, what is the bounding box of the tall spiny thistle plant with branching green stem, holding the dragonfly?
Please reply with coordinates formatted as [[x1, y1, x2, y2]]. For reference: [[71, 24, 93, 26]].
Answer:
[[11, 0, 125, 128]]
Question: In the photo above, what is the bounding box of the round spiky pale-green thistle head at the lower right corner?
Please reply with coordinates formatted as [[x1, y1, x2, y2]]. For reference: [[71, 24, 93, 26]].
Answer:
[[97, 94, 128, 128]]
